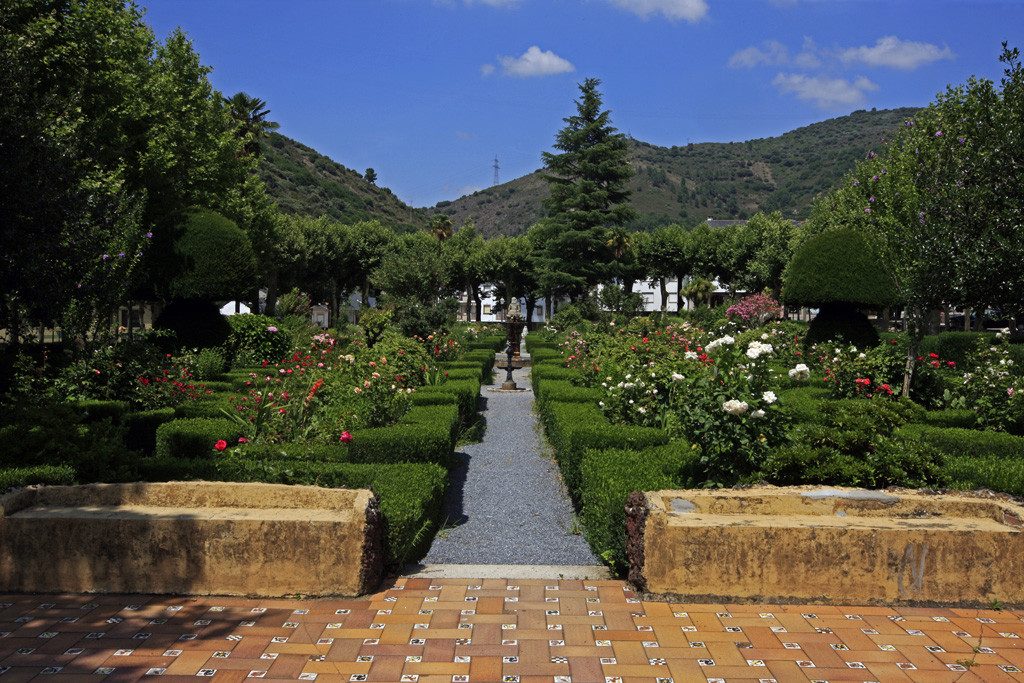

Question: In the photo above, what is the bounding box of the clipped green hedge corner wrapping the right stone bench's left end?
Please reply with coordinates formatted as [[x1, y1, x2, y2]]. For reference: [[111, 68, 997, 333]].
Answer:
[[580, 441, 698, 568]]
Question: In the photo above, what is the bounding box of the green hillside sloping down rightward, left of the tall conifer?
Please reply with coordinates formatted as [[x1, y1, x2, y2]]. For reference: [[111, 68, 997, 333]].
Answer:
[[259, 133, 429, 231]]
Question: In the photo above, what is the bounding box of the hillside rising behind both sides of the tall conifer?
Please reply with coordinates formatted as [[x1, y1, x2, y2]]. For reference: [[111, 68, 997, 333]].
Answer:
[[429, 108, 919, 237]]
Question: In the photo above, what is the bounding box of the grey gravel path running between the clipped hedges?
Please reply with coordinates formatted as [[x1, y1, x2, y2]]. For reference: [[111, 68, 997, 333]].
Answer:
[[422, 368, 600, 565]]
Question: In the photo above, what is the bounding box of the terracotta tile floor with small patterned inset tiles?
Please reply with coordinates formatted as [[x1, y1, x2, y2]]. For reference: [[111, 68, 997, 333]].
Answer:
[[0, 579, 1024, 683]]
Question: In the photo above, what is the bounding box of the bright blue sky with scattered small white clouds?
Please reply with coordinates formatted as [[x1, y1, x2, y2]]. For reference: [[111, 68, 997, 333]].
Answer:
[[139, 0, 1024, 207]]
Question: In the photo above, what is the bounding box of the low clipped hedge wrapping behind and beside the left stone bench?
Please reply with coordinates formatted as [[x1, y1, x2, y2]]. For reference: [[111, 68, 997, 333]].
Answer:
[[139, 449, 447, 567]]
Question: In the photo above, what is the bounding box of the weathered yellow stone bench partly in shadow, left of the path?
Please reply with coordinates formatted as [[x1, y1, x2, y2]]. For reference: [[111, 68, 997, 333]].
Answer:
[[0, 481, 382, 596]]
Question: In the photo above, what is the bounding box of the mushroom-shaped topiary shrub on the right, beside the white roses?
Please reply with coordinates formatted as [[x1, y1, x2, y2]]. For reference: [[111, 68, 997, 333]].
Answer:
[[782, 229, 896, 346]]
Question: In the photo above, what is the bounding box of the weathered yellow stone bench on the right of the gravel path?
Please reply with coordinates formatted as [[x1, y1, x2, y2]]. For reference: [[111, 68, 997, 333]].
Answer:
[[628, 486, 1024, 604]]
